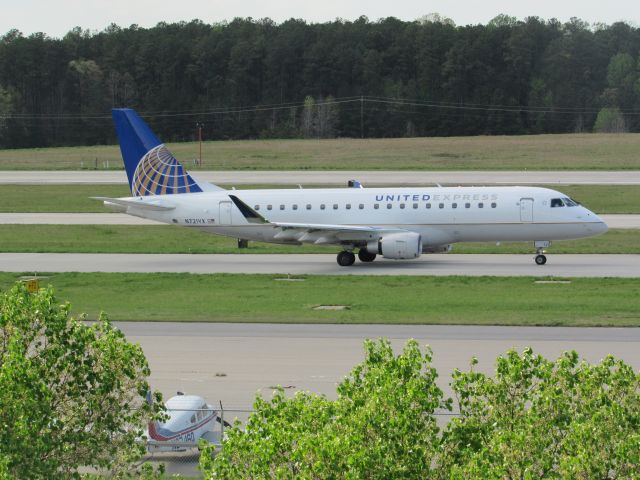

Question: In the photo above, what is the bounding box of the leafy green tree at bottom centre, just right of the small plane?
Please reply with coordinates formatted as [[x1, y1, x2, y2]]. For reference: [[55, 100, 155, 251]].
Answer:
[[200, 340, 451, 479]]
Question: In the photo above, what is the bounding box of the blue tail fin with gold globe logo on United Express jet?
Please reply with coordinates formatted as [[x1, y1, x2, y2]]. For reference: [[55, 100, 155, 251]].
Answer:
[[111, 108, 202, 197]]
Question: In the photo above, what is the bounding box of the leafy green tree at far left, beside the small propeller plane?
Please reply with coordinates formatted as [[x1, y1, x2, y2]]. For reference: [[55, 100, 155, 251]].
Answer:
[[0, 284, 161, 479]]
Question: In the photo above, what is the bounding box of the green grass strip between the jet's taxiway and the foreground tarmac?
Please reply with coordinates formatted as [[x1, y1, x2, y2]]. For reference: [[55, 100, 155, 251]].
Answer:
[[0, 273, 640, 326]]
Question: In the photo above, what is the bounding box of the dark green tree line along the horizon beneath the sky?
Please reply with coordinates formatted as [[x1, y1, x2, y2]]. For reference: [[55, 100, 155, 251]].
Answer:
[[0, 15, 640, 148]]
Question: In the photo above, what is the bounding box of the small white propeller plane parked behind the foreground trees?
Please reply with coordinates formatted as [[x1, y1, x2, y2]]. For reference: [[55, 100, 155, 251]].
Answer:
[[147, 392, 231, 452]]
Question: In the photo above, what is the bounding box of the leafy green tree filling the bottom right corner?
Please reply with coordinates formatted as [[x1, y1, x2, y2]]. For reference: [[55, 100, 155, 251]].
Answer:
[[441, 349, 640, 479]]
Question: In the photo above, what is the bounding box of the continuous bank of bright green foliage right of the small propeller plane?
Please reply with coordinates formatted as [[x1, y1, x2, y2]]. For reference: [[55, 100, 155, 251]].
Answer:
[[200, 340, 640, 479]]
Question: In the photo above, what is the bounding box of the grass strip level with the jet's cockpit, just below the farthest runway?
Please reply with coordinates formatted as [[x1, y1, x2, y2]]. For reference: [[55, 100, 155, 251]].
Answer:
[[0, 185, 640, 213]]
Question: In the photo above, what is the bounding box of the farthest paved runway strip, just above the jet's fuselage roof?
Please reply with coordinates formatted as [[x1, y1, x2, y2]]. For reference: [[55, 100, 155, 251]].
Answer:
[[0, 170, 640, 186]]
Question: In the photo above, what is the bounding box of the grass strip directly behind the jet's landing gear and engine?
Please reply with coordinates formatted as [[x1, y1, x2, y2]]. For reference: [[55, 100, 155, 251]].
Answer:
[[0, 225, 640, 254]]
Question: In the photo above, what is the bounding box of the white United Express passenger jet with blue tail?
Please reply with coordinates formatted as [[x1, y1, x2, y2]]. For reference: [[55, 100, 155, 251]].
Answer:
[[93, 108, 607, 267]]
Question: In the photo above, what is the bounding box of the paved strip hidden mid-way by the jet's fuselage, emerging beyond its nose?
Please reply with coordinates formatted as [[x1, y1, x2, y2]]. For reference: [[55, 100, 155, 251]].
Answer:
[[0, 213, 640, 228]]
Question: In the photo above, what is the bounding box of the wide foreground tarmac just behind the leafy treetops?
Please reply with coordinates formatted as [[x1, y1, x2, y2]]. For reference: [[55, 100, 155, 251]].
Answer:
[[116, 322, 640, 408]]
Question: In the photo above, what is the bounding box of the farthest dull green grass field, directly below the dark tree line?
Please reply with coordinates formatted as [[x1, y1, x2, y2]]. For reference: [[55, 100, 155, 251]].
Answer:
[[0, 133, 640, 170]]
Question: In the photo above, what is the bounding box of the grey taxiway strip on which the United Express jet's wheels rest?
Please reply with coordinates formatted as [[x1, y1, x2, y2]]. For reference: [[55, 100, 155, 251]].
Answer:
[[0, 253, 640, 278]]
